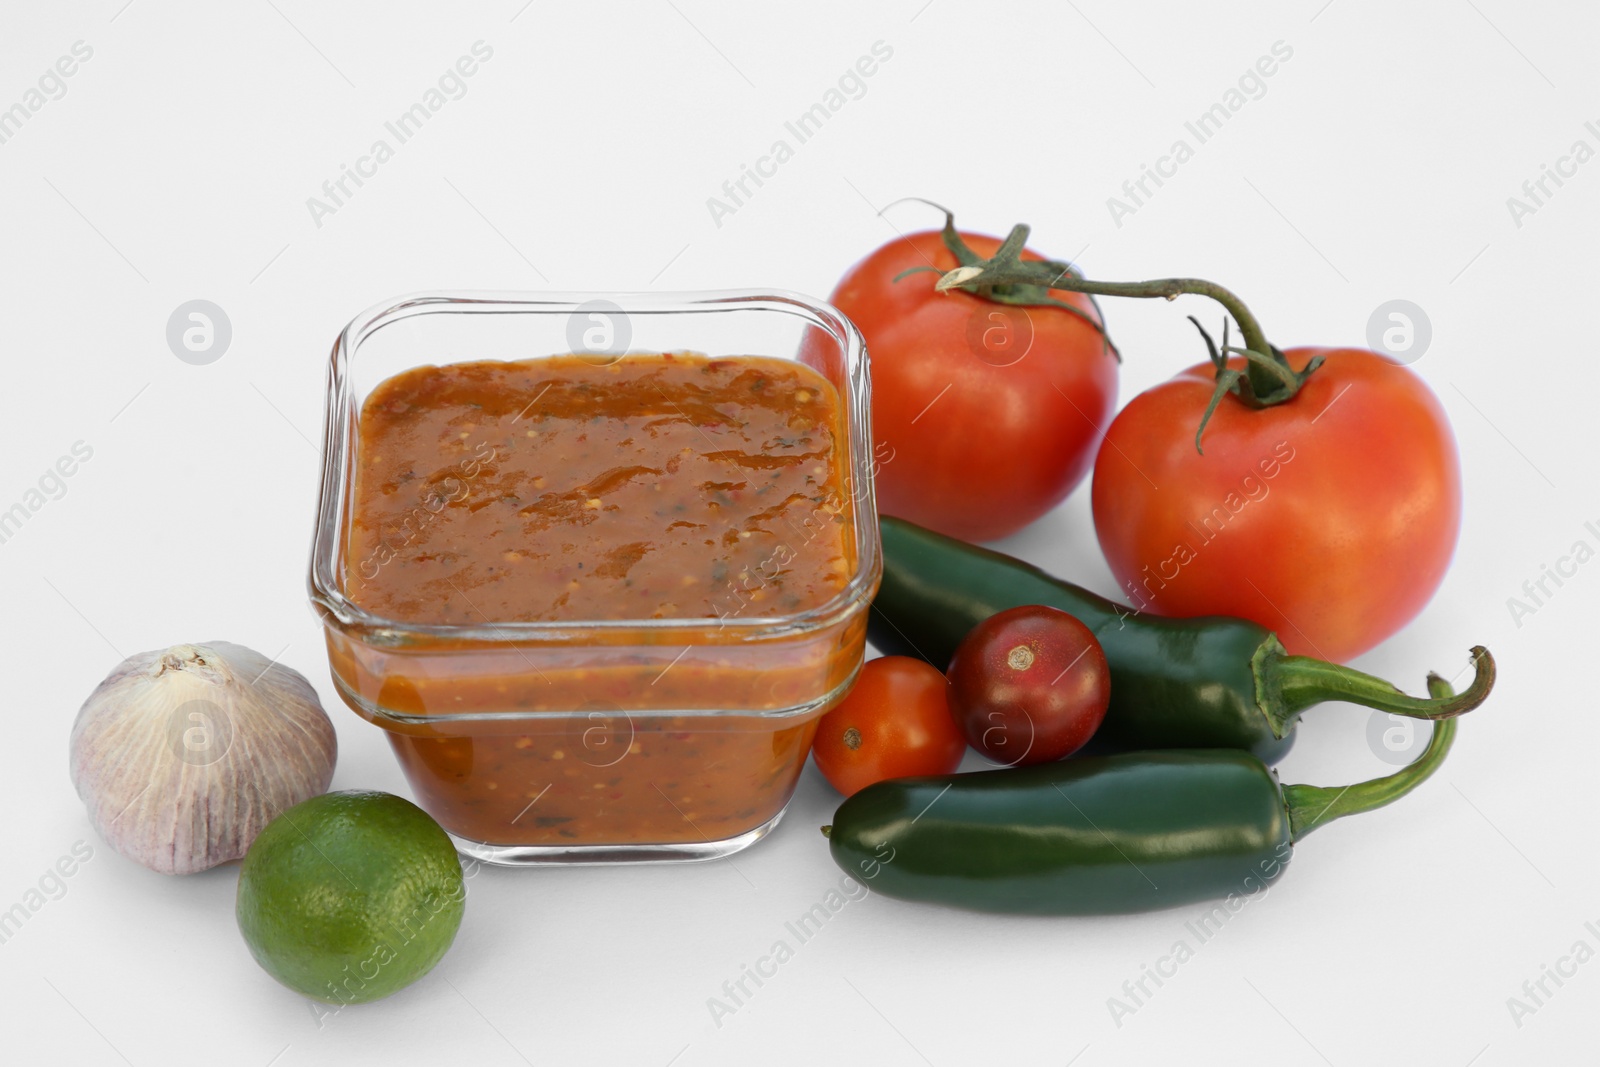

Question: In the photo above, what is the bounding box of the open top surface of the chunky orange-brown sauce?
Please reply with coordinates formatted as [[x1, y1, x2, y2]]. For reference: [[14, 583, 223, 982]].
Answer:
[[349, 354, 853, 625]]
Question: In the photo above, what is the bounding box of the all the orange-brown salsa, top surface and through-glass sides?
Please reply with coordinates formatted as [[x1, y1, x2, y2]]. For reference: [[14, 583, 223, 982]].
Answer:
[[340, 354, 864, 846]]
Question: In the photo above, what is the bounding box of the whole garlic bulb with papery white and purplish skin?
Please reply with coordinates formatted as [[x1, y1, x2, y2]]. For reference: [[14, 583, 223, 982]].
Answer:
[[72, 641, 338, 875]]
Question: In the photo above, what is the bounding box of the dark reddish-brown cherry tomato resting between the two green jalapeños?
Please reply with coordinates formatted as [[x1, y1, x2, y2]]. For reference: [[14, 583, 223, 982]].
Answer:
[[949, 605, 1110, 766]]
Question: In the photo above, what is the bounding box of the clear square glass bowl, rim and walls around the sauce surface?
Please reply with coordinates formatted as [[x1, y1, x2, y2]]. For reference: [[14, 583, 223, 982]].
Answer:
[[310, 291, 882, 865]]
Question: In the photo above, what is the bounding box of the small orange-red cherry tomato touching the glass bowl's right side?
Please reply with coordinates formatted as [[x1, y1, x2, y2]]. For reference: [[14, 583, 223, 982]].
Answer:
[[811, 656, 966, 797]]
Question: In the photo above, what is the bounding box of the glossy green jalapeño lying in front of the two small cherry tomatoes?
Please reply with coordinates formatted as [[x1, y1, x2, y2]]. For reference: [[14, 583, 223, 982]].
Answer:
[[822, 677, 1456, 915]]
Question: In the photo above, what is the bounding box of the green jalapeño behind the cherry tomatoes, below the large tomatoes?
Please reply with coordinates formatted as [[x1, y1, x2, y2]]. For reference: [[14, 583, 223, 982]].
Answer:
[[867, 517, 1494, 763]]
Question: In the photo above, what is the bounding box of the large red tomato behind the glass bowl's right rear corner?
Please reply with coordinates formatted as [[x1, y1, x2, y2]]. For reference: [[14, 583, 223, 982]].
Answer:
[[832, 230, 1117, 541]]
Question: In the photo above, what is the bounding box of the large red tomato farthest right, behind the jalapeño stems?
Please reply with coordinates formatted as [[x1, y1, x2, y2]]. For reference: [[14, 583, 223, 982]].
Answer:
[[1093, 349, 1461, 662]]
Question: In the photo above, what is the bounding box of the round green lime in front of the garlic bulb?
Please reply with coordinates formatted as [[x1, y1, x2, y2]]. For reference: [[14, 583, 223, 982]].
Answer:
[[237, 790, 467, 1005]]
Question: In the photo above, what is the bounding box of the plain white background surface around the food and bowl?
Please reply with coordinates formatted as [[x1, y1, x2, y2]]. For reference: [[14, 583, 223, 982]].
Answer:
[[0, 0, 1600, 1067]]
